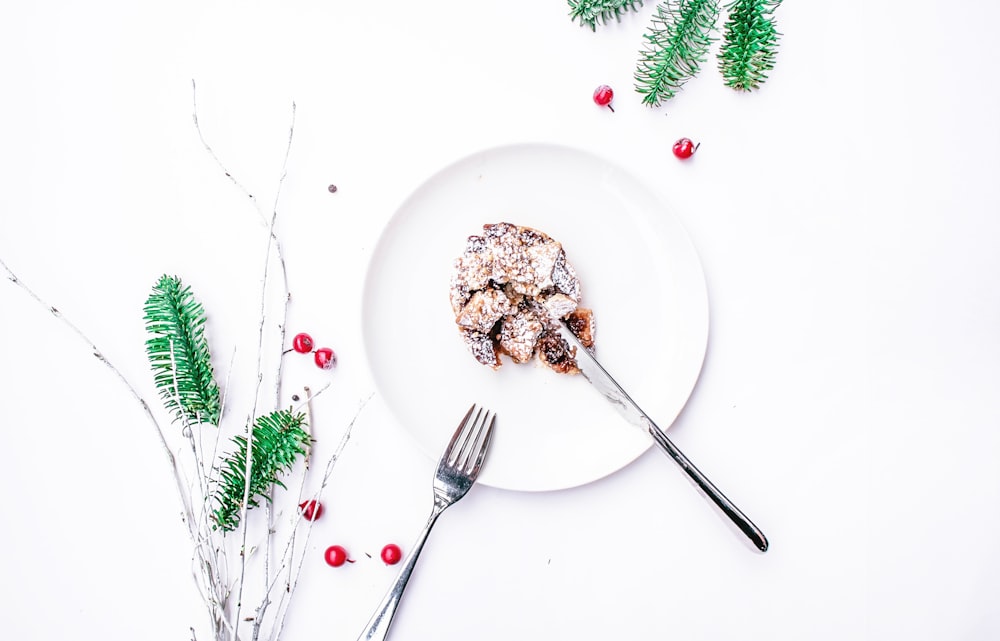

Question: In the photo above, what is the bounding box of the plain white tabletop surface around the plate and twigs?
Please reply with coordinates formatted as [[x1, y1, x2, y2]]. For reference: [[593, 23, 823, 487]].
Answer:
[[0, 0, 1000, 641]]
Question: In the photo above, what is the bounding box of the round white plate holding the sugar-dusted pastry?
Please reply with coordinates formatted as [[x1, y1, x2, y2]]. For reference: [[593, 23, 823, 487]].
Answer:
[[362, 144, 708, 490]]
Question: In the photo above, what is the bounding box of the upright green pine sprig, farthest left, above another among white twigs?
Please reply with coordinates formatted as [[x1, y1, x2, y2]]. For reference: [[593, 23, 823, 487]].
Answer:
[[144, 276, 221, 425]]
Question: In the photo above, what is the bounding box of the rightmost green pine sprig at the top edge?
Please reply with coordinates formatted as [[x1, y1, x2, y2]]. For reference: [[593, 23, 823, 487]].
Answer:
[[719, 0, 781, 91]]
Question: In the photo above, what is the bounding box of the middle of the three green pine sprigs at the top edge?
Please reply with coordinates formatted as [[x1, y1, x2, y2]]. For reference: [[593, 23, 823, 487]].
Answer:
[[635, 0, 719, 107]]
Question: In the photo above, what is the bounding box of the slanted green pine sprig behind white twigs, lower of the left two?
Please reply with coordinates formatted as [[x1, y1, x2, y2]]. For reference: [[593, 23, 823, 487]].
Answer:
[[213, 409, 311, 532]]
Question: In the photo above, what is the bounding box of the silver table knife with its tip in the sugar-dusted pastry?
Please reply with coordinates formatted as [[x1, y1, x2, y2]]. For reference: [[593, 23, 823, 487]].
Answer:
[[555, 320, 768, 552]]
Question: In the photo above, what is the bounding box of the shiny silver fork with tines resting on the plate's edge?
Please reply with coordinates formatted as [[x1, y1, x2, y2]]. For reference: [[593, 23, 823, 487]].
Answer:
[[358, 404, 497, 641]]
